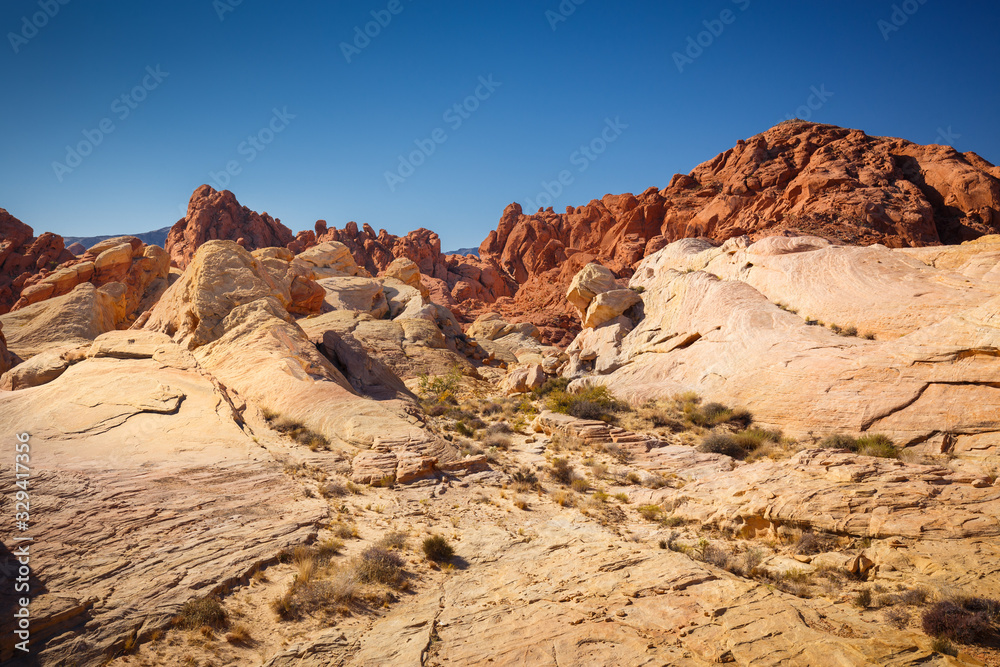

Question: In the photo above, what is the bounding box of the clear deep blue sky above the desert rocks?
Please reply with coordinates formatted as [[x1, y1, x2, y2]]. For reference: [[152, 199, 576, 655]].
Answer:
[[0, 0, 1000, 249]]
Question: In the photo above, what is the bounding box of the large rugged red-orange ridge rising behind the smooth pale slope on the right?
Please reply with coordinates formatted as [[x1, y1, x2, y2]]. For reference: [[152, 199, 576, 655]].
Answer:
[[479, 121, 1000, 338]]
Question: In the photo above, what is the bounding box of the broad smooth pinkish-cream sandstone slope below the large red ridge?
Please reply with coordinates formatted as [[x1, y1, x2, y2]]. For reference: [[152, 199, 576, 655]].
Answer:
[[571, 237, 1000, 474]]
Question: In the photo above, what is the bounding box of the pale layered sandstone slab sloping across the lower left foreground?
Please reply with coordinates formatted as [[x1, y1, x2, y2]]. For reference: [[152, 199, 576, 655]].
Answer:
[[0, 332, 327, 665]]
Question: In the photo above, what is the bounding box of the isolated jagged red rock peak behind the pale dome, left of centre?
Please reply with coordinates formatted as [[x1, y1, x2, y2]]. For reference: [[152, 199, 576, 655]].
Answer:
[[166, 185, 294, 269]]
